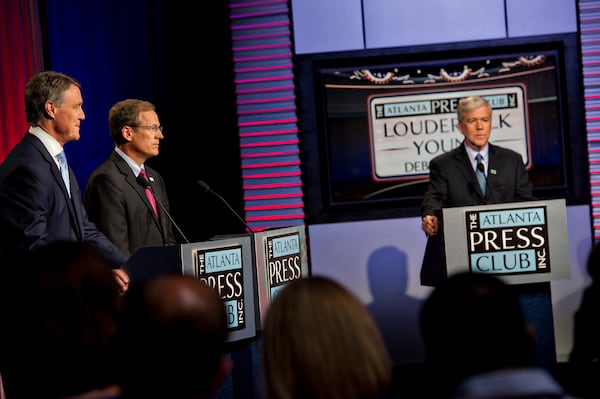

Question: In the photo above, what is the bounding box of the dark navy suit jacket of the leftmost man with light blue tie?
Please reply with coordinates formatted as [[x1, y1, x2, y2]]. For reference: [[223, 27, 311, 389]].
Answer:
[[0, 133, 128, 268]]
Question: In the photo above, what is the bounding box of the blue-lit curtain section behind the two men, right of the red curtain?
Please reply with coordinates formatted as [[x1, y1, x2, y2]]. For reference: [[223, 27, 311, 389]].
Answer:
[[42, 0, 166, 189]]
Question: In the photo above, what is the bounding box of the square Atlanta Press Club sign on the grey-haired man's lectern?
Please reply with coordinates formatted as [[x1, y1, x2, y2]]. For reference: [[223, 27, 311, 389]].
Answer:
[[465, 206, 550, 275]]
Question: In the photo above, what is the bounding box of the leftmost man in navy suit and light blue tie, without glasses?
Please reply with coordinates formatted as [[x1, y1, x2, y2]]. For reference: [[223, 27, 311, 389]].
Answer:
[[0, 71, 129, 290]]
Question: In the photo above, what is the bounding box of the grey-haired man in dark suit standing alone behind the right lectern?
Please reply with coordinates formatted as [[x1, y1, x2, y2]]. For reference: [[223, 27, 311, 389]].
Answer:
[[421, 96, 535, 286]]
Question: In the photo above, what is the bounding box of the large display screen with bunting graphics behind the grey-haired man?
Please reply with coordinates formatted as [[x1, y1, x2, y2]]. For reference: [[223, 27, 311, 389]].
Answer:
[[299, 34, 585, 221]]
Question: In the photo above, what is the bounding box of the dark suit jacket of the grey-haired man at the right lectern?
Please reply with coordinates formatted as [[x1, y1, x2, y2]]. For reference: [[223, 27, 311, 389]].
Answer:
[[421, 142, 536, 286]]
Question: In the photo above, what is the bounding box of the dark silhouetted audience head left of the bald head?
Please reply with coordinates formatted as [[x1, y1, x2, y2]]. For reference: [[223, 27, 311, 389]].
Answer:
[[18, 241, 121, 398]]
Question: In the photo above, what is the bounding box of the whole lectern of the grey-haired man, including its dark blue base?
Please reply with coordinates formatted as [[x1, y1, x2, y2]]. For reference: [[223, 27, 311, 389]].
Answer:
[[421, 199, 571, 367]]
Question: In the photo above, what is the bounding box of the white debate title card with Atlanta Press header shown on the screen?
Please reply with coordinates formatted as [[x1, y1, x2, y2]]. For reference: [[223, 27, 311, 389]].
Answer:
[[368, 84, 530, 181]]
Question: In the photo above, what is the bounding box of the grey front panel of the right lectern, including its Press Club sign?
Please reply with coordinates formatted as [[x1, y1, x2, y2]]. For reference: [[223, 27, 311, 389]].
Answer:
[[442, 199, 571, 284]]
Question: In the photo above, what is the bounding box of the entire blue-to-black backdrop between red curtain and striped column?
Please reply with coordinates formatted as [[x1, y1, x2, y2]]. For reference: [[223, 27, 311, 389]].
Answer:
[[41, 0, 244, 242]]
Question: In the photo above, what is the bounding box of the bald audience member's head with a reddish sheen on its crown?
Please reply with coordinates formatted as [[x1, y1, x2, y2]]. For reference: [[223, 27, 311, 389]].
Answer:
[[117, 275, 231, 399]]
